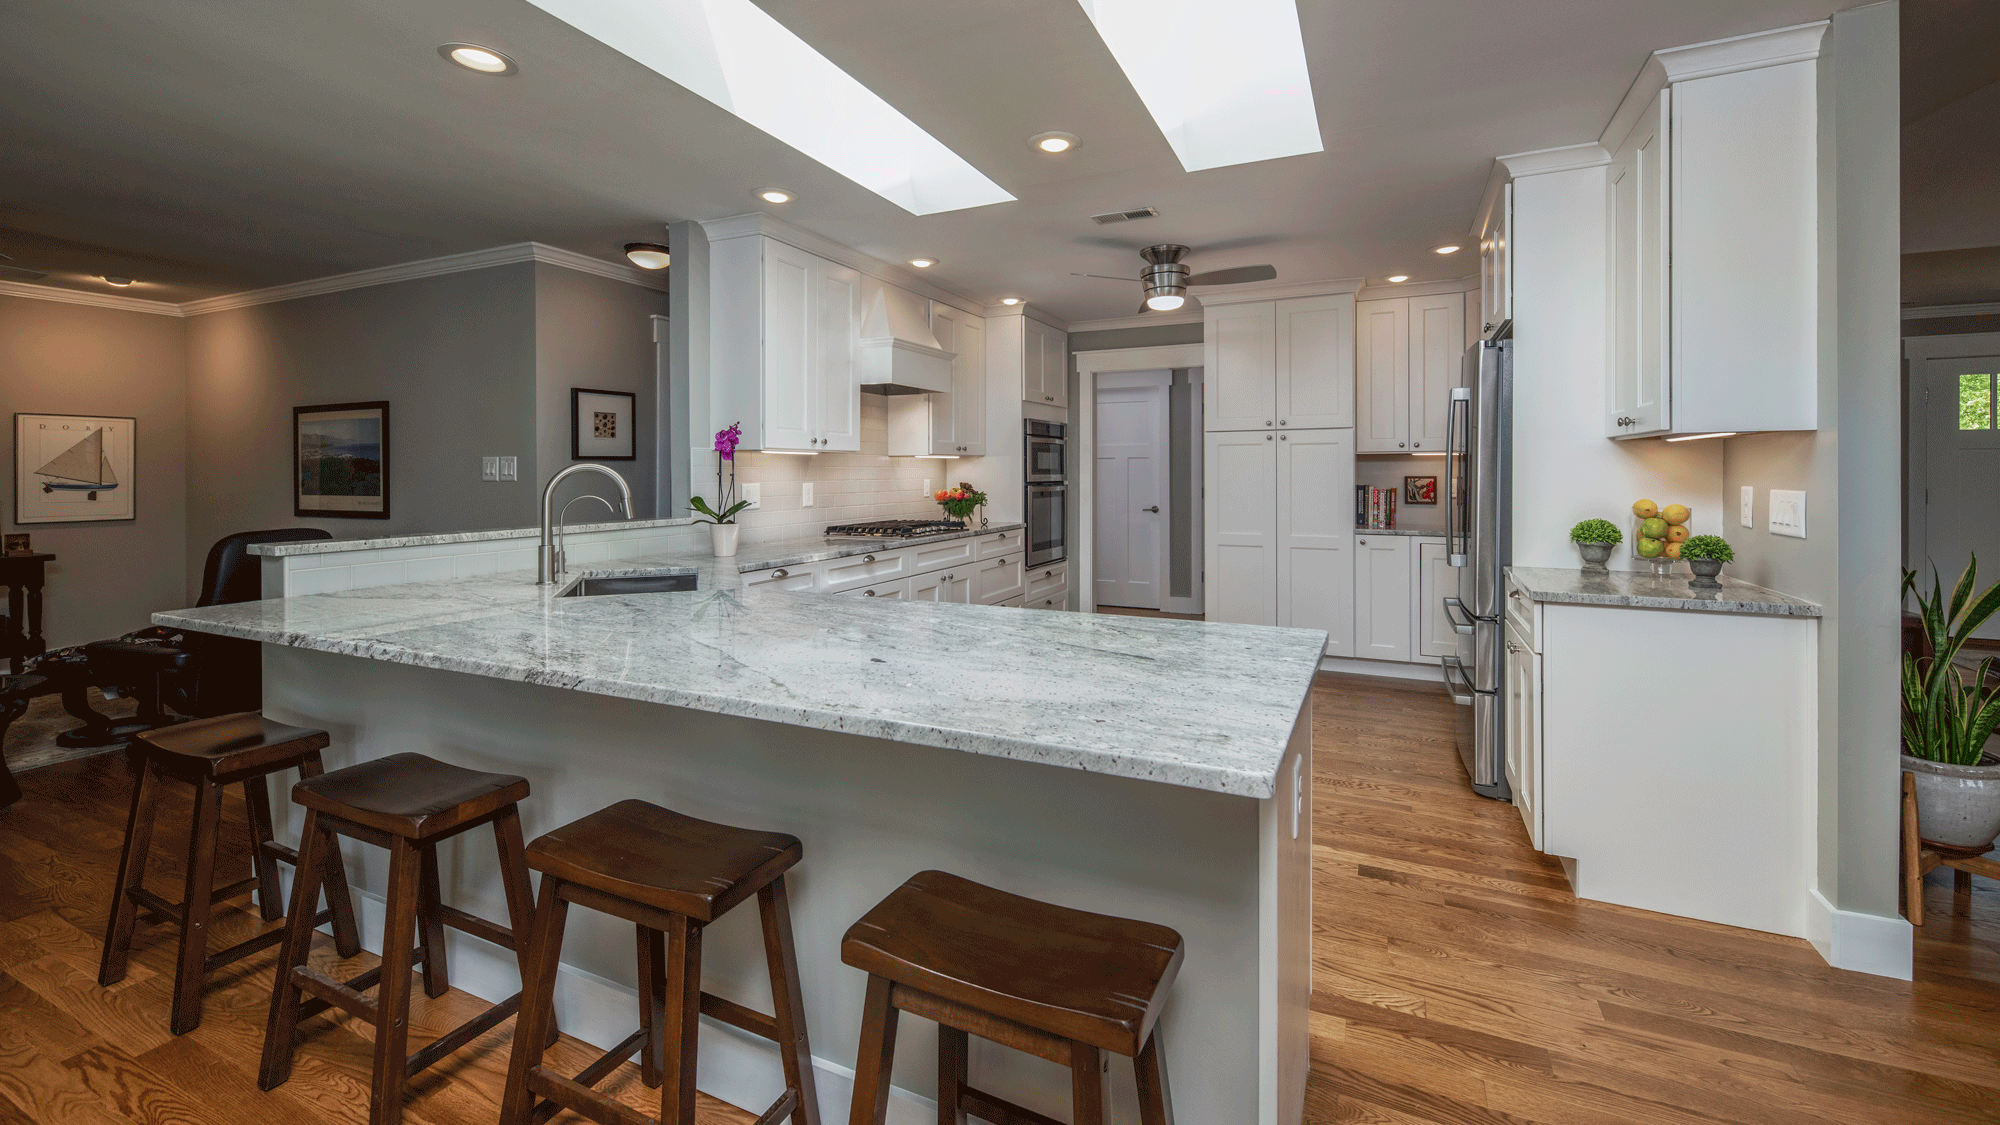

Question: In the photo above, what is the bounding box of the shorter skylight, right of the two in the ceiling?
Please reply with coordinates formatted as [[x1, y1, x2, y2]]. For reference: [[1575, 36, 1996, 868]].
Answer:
[[1076, 0, 1326, 172]]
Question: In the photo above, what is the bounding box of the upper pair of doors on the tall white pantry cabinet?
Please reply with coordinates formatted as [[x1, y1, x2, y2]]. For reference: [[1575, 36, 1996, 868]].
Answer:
[[1202, 292, 1354, 432]]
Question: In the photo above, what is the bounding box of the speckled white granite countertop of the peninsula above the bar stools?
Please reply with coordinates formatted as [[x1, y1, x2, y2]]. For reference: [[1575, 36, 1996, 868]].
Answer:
[[152, 528, 1326, 799]]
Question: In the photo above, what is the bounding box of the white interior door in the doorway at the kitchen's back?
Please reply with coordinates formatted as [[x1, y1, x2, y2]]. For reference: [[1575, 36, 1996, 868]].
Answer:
[[1092, 370, 1174, 609]]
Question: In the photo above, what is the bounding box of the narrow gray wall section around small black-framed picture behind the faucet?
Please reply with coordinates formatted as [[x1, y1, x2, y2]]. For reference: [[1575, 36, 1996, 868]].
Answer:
[[526, 262, 666, 522]]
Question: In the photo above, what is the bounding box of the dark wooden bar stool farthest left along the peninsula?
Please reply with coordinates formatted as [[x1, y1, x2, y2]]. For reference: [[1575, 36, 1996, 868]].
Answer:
[[98, 711, 362, 1035]]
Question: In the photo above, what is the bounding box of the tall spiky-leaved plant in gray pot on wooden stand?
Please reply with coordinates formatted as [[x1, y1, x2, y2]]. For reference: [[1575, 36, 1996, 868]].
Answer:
[[1902, 556, 2000, 855]]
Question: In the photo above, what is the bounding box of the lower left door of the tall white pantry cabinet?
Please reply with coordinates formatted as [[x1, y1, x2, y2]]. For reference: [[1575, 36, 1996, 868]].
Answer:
[[1202, 430, 1278, 625]]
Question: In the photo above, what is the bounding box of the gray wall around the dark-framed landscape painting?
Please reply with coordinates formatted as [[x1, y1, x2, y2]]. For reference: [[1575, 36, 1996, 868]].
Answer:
[[184, 262, 536, 593]]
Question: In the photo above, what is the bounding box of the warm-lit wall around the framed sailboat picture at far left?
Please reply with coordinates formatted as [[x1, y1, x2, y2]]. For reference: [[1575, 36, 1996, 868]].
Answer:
[[0, 296, 189, 647]]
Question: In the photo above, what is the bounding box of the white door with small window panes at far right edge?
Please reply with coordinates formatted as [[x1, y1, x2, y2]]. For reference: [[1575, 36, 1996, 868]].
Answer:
[[1920, 356, 2000, 637]]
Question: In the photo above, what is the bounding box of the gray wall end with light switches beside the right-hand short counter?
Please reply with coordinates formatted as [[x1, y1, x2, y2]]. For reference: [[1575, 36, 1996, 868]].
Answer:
[[1724, 4, 1902, 917]]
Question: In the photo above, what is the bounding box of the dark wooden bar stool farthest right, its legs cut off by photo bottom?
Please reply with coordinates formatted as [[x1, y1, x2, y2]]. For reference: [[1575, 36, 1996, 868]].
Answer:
[[840, 871, 1182, 1125]]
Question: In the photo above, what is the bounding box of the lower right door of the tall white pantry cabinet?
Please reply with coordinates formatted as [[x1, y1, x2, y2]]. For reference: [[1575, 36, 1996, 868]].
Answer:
[[1278, 430, 1354, 657]]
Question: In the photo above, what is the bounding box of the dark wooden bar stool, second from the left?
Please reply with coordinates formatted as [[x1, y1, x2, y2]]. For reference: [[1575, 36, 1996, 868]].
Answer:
[[258, 755, 532, 1125]]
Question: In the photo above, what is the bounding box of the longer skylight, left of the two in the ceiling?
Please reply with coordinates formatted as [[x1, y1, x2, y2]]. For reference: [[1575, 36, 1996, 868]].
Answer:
[[530, 0, 1014, 214]]
